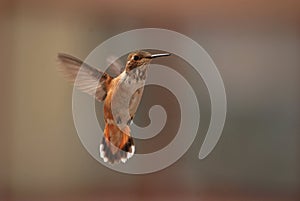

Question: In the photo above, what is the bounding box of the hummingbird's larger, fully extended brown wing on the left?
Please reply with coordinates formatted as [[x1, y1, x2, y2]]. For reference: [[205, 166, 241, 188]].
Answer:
[[58, 53, 112, 102]]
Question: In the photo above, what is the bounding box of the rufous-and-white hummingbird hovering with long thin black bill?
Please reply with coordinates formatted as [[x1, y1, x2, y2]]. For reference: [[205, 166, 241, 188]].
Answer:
[[58, 51, 171, 164]]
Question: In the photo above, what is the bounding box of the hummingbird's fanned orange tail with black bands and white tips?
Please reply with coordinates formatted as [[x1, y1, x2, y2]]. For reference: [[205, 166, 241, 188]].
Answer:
[[100, 124, 135, 164]]
